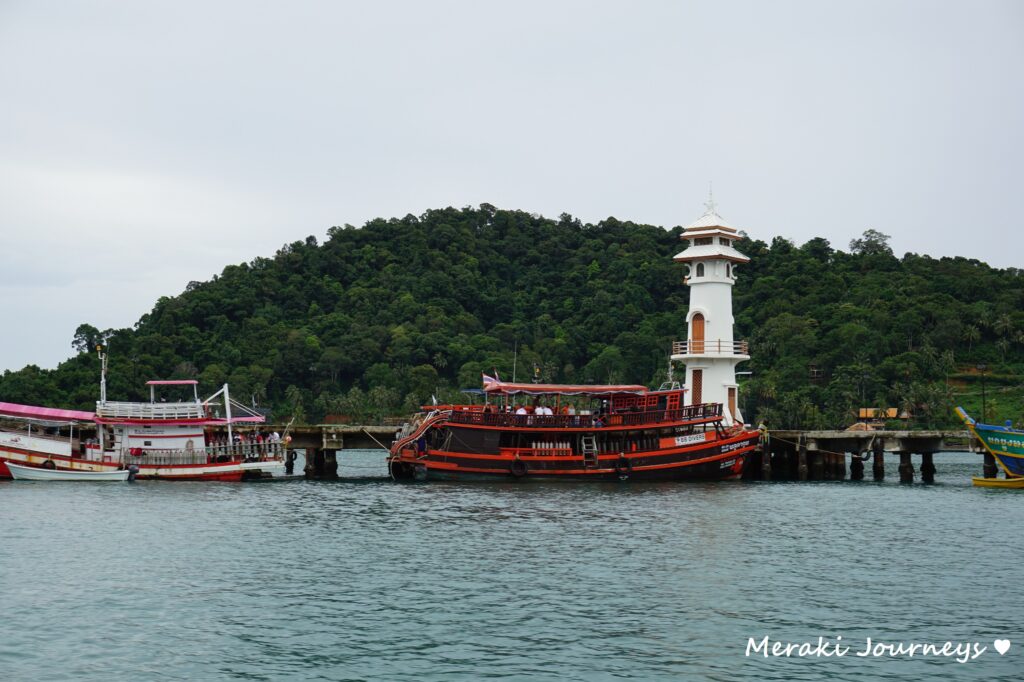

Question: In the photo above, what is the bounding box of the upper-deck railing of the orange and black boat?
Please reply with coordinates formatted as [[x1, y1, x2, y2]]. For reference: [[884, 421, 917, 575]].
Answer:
[[449, 402, 722, 429]]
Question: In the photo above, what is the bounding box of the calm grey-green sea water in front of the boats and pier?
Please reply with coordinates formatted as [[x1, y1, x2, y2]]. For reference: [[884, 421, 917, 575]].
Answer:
[[0, 452, 1024, 681]]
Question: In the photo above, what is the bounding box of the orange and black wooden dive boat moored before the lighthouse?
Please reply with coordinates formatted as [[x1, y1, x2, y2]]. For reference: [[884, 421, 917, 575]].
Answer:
[[388, 377, 759, 480]]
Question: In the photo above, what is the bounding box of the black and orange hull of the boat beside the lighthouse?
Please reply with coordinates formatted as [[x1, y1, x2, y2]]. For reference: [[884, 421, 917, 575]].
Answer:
[[390, 431, 758, 480]]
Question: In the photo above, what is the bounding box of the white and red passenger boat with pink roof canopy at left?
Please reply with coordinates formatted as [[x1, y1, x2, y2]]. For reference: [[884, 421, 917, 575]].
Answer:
[[0, 349, 285, 480]]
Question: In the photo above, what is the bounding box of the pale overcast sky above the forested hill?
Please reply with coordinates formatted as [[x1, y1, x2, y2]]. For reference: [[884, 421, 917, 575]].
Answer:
[[0, 0, 1024, 370]]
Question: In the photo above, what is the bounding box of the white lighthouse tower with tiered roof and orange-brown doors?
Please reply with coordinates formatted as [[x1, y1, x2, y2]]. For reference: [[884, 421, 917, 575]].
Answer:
[[672, 195, 751, 425]]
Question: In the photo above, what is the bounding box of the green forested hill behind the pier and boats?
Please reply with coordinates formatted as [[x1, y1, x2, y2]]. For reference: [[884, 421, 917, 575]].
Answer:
[[0, 205, 1024, 427]]
